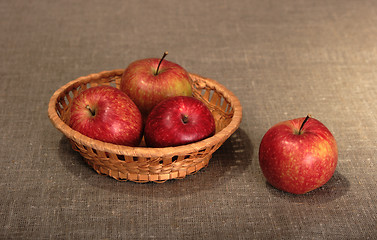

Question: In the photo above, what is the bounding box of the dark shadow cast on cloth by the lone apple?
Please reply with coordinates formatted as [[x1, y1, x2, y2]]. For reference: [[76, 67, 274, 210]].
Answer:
[[266, 171, 350, 204]]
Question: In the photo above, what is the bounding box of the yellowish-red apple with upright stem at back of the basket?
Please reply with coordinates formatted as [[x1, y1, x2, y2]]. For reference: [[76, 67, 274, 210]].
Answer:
[[120, 58, 192, 119]]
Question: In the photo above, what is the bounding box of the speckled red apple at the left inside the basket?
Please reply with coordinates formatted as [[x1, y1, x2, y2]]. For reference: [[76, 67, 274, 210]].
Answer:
[[69, 86, 143, 146]]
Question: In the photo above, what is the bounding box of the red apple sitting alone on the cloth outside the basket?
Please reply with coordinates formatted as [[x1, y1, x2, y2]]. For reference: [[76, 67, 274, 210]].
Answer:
[[259, 118, 338, 194]]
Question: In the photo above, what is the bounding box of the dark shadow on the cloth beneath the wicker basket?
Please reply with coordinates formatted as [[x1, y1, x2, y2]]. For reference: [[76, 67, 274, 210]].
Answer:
[[59, 129, 254, 198]]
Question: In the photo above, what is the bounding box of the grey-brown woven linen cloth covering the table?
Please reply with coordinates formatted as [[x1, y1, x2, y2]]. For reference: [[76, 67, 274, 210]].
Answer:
[[0, 0, 377, 239]]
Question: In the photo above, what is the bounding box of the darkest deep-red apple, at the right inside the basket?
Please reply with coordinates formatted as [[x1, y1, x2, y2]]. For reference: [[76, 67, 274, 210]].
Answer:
[[144, 96, 216, 147]]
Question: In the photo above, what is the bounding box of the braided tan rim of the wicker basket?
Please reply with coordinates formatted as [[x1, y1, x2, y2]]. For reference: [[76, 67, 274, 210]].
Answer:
[[48, 69, 242, 158]]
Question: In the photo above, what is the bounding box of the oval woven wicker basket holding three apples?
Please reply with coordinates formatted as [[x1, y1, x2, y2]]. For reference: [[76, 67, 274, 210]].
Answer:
[[48, 69, 242, 182]]
